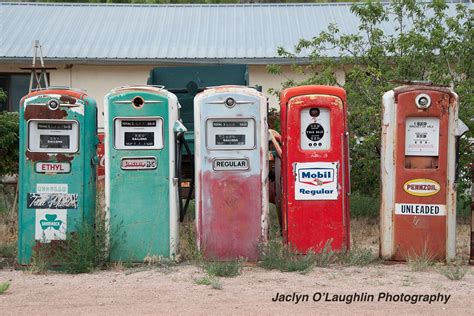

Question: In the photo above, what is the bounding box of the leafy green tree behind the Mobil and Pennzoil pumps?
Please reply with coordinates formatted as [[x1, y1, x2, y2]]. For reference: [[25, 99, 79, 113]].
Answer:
[[269, 0, 474, 196]]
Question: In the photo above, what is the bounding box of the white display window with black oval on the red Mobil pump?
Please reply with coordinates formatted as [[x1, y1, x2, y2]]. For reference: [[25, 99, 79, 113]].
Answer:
[[300, 107, 331, 150]]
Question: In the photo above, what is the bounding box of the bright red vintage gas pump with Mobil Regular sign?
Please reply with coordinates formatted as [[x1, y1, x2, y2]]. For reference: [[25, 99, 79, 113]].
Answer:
[[280, 86, 350, 253]]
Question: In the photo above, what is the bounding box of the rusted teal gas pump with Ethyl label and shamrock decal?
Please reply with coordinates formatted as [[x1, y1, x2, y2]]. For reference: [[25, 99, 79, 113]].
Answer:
[[18, 88, 97, 264]]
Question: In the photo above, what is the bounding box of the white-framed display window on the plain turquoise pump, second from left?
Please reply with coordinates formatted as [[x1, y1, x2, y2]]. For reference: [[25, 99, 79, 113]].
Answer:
[[114, 117, 163, 149]]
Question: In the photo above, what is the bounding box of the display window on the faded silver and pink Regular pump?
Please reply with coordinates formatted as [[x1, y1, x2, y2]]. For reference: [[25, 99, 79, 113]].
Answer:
[[206, 117, 255, 150]]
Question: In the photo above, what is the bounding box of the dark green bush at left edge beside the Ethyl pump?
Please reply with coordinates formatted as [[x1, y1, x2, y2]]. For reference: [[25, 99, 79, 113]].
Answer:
[[0, 112, 19, 176]]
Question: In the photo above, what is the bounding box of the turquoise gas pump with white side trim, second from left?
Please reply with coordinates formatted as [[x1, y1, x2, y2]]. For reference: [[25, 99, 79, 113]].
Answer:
[[105, 86, 186, 262]]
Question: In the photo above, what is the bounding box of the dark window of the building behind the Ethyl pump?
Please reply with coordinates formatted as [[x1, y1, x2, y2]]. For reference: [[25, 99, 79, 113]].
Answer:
[[0, 73, 44, 112]]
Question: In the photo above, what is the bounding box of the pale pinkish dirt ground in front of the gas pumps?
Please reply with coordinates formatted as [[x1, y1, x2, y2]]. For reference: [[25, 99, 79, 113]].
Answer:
[[0, 221, 474, 315]]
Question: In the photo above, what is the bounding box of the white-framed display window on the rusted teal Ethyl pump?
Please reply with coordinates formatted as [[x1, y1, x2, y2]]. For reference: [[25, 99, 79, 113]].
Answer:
[[28, 120, 79, 153]]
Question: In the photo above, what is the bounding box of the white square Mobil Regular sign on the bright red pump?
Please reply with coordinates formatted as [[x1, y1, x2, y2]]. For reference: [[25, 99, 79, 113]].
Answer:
[[295, 162, 338, 200]]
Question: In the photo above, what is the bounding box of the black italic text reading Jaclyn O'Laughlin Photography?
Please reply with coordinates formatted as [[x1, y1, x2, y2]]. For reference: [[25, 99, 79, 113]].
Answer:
[[272, 292, 451, 304]]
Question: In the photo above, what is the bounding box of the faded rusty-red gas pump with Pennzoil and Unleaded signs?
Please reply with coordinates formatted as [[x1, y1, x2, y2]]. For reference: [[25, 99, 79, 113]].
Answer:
[[380, 85, 459, 260]]
